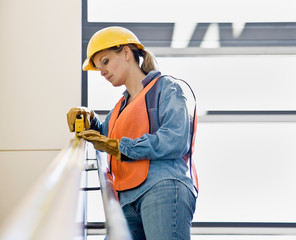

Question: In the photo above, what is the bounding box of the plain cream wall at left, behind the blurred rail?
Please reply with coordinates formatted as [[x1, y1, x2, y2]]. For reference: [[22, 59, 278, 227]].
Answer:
[[0, 0, 81, 224]]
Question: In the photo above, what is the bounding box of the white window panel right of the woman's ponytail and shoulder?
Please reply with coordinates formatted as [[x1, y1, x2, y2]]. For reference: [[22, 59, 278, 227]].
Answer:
[[158, 56, 296, 111]]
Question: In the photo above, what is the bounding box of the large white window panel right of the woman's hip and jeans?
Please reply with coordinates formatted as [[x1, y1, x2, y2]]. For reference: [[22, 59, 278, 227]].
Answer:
[[194, 123, 296, 222]]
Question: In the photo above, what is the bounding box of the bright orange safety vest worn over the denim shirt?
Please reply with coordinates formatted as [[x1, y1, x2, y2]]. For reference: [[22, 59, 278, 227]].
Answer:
[[108, 78, 158, 191]]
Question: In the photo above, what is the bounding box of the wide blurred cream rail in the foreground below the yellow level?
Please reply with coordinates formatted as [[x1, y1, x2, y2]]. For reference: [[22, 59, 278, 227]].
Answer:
[[0, 138, 86, 240]]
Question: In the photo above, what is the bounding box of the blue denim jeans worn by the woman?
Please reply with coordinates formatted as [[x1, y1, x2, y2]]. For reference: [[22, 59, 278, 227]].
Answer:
[[123, 180, 196, 240]]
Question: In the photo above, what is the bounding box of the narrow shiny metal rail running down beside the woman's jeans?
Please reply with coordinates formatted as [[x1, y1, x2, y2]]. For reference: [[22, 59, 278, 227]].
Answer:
[[96, 151, 132, 240]]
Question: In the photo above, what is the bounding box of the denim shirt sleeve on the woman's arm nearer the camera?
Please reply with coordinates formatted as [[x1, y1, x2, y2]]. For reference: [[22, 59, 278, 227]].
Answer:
[[119, 81, 190, 161]]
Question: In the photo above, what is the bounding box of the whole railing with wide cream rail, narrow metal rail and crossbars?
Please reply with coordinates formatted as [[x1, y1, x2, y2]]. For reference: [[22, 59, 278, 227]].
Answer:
[[0, 135, 132, 240]]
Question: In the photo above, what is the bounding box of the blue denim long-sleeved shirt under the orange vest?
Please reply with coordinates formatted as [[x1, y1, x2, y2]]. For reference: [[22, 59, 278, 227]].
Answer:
[[91, 71, 196, 206]]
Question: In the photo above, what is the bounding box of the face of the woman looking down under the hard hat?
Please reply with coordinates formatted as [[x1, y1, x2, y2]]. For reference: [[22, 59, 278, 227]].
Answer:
[[93, 49, 128, 87]]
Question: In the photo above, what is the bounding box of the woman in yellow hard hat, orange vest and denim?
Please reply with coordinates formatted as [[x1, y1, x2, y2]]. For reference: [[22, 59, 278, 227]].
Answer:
[[67, 27, 197, 240]]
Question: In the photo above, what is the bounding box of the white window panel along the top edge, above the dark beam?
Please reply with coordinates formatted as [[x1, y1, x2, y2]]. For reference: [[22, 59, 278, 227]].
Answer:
[[88, 0, 296, 22]]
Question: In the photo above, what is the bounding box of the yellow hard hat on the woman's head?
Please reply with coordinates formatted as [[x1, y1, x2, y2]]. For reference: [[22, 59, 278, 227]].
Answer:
[[82, 27, 144, 71]]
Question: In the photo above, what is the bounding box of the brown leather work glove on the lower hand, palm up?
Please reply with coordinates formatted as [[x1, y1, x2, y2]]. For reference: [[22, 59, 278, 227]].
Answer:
[[77, 130, 121, 161]]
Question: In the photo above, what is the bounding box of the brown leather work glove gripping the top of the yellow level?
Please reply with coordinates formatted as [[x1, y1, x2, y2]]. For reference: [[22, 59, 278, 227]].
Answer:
[[67, 107, 95, 132]]
